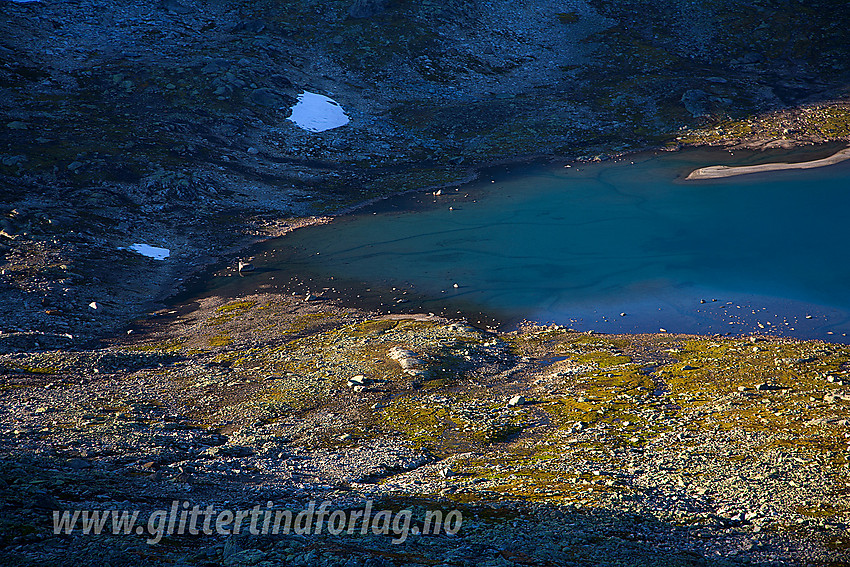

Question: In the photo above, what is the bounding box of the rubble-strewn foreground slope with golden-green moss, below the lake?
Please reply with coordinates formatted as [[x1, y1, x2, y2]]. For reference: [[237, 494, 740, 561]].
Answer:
[[0, 295, 850, 565]]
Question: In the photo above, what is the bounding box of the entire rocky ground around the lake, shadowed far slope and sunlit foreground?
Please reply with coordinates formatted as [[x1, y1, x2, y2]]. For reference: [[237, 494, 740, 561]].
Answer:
[[0, 0, 850, 566]]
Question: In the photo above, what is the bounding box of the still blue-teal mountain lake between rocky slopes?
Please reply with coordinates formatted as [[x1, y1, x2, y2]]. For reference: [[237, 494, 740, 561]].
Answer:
[[200, 148, 850, 342]]
